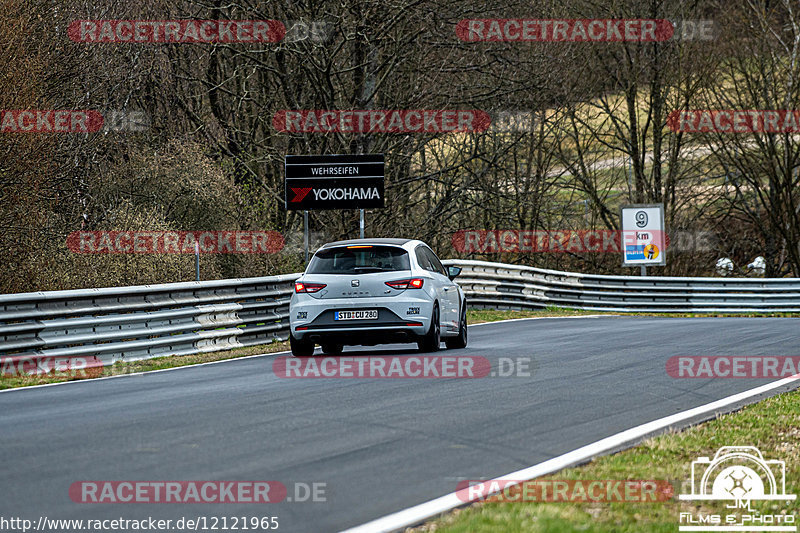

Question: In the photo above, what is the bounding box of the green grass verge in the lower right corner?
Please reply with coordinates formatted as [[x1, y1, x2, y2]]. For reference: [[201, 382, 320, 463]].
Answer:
[[406, 390, 800, 533]]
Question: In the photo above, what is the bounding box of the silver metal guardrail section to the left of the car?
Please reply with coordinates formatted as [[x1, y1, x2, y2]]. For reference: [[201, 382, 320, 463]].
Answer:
[[0, 274, 300, 374]]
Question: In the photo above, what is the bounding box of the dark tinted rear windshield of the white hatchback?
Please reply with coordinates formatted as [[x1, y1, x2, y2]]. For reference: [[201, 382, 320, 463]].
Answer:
[[308, 245, 411, 274]]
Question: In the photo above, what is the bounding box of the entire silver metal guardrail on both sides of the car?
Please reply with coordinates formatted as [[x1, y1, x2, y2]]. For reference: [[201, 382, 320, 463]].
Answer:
[[0, 259, 800, 374]]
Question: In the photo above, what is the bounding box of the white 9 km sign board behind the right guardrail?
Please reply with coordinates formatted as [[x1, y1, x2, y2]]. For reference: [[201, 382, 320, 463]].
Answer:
[[620, 204, 667, 276]]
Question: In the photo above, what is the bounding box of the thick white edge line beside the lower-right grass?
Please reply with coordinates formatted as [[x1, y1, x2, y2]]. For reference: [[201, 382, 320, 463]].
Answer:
[[342, 377, 800, 533]]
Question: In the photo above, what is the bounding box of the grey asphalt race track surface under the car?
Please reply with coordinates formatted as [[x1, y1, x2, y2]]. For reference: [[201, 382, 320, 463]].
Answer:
[[0, 317, 800, 532]]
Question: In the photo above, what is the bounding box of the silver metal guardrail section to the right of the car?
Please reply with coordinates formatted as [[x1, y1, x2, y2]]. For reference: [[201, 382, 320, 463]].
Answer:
[[443, 259, 800, 313]]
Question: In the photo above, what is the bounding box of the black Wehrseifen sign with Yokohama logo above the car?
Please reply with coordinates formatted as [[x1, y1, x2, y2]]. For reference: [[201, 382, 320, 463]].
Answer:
[[285, 154, 384, 210]]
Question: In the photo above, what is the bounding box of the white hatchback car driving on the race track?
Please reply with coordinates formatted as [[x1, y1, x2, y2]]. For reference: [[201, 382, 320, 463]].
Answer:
[[289, 239, 467, 356]]
